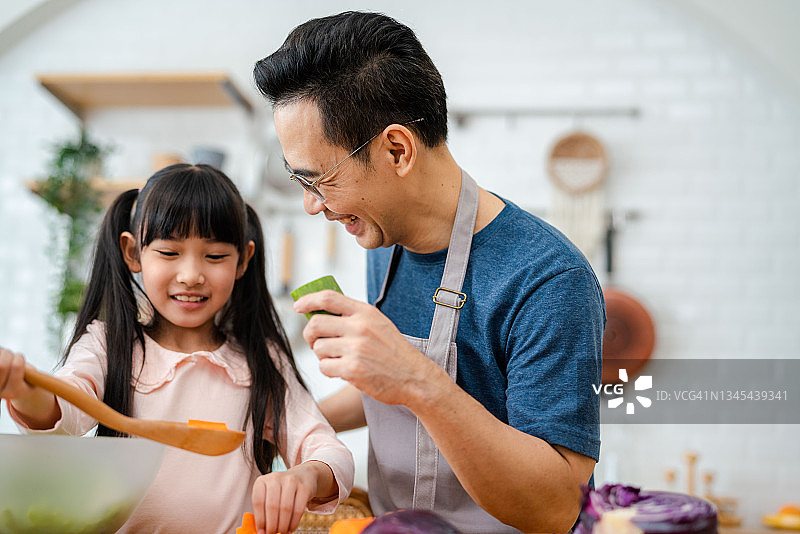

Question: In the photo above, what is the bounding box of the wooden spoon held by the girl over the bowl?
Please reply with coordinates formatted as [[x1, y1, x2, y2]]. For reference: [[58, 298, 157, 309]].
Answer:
[[25, 366, 244, 456]]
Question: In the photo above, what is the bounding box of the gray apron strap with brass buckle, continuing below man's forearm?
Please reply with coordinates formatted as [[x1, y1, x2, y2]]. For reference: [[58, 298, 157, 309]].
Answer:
[[412, 171, 478, 510]]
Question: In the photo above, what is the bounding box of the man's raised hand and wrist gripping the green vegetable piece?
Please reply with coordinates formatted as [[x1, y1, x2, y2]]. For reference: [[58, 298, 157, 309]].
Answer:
[[294, 290, 452, 406]]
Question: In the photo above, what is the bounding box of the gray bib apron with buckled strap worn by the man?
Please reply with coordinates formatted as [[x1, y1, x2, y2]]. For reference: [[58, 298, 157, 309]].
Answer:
[[362, 171, 519, 534]]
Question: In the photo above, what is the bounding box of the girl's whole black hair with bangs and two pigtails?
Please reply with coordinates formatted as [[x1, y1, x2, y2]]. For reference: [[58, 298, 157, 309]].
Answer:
[[62, 164, 303, 473]]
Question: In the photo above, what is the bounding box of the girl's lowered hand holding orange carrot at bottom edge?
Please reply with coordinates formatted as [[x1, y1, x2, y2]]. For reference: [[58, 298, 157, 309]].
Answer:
[[253, 461, 332, 534]]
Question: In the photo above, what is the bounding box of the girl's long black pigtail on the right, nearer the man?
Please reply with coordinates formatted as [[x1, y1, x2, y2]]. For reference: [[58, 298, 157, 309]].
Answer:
[[228, 206, 305, 473]]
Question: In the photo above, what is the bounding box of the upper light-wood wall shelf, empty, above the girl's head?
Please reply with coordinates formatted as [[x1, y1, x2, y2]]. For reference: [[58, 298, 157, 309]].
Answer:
[[36, 72, 253, 120]]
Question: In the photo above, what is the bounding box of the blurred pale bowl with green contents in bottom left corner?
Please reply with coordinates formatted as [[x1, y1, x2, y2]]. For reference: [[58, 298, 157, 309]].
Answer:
[[0, 434, 165, 534]]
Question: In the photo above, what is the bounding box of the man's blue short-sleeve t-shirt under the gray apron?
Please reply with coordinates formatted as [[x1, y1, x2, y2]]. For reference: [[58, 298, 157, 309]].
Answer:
[[367, 201, 605, 460]]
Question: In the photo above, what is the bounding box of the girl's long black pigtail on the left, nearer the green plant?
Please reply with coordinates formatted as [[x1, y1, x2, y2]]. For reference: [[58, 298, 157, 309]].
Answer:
[[62, 189, 144, 436]]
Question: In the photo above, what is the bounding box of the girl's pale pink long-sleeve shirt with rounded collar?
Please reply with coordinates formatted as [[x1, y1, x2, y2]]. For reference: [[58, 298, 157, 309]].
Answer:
[[9, 321, 354, 533]]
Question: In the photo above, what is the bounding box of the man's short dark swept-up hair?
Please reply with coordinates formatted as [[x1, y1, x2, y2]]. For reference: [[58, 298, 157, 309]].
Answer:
[[253, 11, 447, 162]]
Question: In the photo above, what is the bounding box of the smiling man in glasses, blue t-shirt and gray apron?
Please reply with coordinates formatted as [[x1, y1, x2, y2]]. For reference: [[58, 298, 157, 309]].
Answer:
[[254, 12, 605, 532]]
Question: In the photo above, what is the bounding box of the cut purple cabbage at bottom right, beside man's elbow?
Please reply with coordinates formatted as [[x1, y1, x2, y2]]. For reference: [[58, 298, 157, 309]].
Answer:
[[575, 484, 717, 534]]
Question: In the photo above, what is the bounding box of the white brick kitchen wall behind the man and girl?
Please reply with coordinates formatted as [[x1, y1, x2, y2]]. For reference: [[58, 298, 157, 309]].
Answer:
[[0, 0, 800, 524]]
